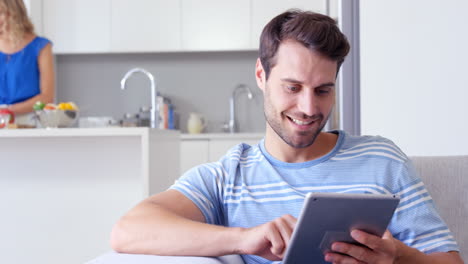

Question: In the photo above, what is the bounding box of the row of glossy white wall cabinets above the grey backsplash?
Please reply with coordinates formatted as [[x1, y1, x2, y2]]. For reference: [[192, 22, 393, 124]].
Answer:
[[37, 0, 327, 54]]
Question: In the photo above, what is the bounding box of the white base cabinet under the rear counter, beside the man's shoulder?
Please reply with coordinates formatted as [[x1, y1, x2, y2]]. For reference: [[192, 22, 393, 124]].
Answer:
[[180, 133, 264, 174]]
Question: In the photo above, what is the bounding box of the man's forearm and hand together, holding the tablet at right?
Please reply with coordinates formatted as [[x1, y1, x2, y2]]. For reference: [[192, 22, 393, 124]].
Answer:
[[325, 230, 463, 264]]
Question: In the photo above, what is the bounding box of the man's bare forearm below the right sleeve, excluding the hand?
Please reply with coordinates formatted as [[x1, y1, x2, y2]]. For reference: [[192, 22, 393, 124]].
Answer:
[[395, 241, 463, 264]]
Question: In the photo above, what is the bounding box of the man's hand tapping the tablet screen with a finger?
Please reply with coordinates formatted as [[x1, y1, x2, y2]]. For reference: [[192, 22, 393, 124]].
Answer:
[[239, 215, 297, 260]]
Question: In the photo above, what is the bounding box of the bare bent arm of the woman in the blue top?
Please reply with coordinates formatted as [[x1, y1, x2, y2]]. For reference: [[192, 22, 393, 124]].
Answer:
[[9, 43, 55, 114]]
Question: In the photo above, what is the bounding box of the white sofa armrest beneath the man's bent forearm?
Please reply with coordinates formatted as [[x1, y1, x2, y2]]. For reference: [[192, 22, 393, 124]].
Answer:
[[86, 252, 244, 264]]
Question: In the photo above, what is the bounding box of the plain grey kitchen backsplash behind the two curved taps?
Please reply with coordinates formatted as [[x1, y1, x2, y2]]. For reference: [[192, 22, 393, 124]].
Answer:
[[56, 51, 265, 132]]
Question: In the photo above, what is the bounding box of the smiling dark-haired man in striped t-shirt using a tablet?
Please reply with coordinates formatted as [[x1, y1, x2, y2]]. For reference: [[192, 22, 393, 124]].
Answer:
[[112, 11, 462, 264]]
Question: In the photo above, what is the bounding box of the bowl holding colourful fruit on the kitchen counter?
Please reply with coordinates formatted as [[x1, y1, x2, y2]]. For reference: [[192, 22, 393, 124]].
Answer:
[[36, 109, 78, 128]]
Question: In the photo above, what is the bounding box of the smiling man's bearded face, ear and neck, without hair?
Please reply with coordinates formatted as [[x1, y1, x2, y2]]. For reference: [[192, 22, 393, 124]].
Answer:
[[256, 39, 340, 162]]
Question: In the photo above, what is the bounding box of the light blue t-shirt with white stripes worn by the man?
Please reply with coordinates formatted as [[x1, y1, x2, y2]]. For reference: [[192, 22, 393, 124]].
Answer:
[[171, 131, 459, 264]]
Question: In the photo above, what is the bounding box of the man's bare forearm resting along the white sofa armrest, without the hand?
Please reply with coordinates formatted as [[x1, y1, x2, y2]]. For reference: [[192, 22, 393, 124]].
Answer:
[[111, 203, 241, 256]]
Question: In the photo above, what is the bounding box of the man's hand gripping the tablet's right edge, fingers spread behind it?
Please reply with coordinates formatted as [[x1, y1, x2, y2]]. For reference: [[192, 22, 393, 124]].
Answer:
[[325, 230, 398, 264]]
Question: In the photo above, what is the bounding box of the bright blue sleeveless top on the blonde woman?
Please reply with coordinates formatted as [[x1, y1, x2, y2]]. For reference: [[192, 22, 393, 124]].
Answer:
[[0, 37, 51, 105]]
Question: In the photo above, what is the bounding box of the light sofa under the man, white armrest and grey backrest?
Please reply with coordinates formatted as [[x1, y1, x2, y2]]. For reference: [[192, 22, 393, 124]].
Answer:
[[87, 156, 468, 264]]
